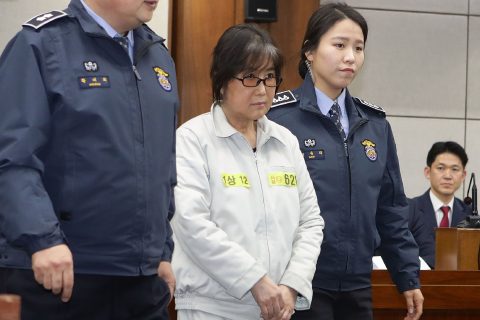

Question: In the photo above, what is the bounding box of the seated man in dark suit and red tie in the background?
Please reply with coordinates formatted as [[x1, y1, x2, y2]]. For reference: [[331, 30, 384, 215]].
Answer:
[[408, 141, 472, 268]]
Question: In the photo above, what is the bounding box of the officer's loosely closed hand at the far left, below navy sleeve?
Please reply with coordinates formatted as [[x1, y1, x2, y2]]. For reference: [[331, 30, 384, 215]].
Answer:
[[32, 244, 73, 302]]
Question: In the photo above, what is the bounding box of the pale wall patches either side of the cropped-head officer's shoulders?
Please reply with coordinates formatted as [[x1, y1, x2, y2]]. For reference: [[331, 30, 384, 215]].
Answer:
[[0, 0, 169, 51]]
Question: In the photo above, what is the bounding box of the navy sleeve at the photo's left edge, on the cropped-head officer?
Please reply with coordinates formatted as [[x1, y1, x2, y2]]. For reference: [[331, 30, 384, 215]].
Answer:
[[0, 31, 64, 254]]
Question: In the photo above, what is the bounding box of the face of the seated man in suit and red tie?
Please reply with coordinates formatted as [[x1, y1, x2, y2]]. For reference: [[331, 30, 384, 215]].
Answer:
[[424, 153, 466, 201]]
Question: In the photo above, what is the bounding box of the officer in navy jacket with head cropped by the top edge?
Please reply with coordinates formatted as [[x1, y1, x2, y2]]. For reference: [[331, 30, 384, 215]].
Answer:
[[0, 0, 178, 320]]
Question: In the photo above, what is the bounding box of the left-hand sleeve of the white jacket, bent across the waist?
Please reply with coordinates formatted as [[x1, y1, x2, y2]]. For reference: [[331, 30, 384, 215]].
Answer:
[[172, 128, 267, 299]]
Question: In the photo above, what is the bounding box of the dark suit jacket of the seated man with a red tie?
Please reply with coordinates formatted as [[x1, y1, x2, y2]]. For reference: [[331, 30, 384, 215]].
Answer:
[[408, 189, 472, 268]]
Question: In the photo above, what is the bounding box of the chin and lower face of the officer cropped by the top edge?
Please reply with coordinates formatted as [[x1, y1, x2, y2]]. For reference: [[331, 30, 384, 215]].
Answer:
[[86, 0, 158, 33]]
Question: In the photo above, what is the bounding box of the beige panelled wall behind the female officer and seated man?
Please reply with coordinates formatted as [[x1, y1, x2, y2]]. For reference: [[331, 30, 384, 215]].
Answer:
[[338, 0, 480, 198]]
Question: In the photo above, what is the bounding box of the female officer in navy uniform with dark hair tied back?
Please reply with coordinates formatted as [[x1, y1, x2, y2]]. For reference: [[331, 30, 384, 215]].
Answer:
[[268, 3, 423, 320]]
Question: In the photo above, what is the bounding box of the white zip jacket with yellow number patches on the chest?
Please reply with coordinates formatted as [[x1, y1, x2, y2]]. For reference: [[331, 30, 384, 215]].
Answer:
[[172, 105, 324, 319]]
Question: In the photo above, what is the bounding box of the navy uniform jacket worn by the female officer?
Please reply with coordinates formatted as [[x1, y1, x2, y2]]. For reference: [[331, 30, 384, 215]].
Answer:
[[268, 75, 419, 292]]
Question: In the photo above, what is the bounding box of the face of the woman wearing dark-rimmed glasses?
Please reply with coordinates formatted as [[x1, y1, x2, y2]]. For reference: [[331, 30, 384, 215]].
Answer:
[[222, 62, 276, 124]]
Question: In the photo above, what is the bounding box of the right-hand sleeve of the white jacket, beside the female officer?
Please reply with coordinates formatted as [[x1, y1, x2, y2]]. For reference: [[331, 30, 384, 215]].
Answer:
[[280, 136, 324, 310]]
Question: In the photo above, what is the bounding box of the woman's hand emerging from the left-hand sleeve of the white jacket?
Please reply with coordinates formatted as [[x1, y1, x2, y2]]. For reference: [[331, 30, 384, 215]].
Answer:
[[250, 276, 285, 320]]
